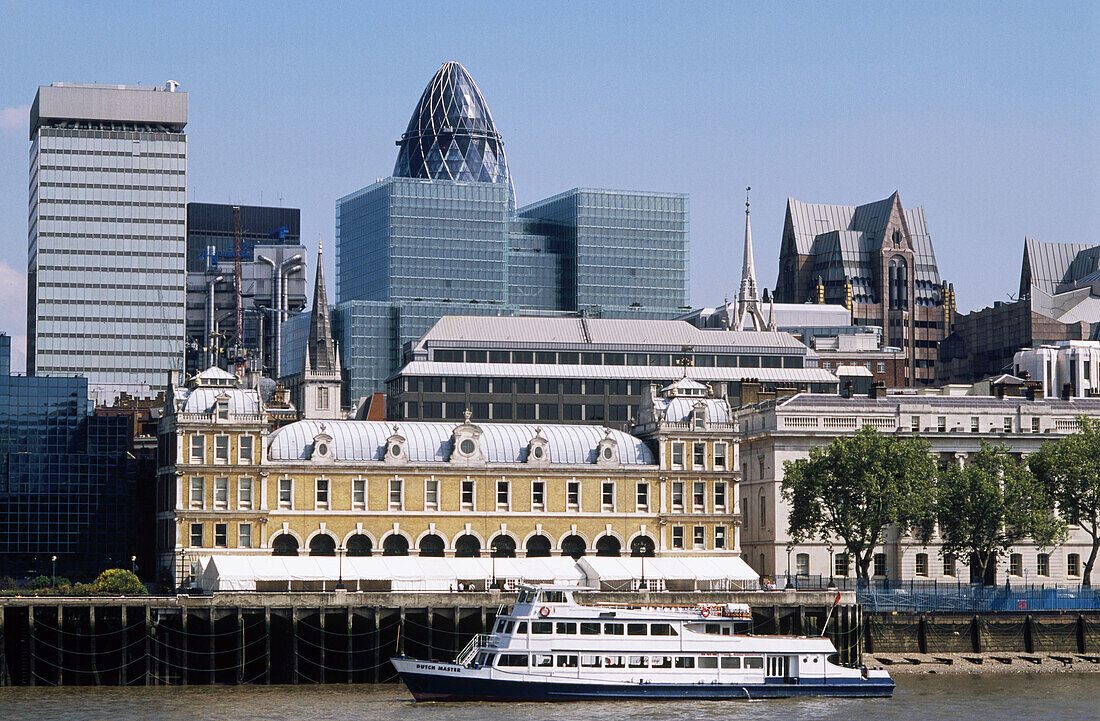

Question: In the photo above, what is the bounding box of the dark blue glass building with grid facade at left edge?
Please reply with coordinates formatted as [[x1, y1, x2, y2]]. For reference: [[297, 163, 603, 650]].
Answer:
[[0, 334, 136, 578]]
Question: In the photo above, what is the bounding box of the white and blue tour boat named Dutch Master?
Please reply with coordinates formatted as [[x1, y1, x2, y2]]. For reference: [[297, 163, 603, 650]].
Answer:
[[392, 586, 894, 701]]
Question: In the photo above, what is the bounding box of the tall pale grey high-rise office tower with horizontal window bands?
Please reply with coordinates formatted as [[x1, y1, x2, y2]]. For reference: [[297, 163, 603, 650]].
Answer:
[[26, 81, 187, 402]]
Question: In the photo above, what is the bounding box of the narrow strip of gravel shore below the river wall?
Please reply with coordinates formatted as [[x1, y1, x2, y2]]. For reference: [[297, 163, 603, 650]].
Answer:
[[864, 652, 1100, 676]]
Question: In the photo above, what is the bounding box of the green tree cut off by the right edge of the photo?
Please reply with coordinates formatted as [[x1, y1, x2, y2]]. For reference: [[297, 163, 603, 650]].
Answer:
[[1027, 417, 1100, 586]]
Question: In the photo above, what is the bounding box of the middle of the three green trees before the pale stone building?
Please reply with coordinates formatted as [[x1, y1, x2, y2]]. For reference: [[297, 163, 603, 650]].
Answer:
[[936, 440, 1066, 579]]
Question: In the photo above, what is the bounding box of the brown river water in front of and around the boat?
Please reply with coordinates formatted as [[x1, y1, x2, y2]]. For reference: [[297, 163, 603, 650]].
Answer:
[[0, 674, 1100, 721]]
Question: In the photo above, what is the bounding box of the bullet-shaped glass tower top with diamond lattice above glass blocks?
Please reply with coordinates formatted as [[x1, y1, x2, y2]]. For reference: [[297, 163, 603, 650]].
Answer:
[[394, 62, 515, 206]]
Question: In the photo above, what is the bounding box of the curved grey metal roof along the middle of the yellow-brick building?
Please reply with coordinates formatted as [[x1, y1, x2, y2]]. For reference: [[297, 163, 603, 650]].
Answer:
[[268, 420, 656, 466]]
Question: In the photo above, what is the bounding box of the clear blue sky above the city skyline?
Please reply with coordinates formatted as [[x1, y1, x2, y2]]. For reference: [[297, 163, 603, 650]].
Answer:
[[0, 0, 1100, 370]]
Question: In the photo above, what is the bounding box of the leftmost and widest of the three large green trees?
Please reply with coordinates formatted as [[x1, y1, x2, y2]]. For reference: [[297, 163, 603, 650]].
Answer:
[[782, 426, 936, 579]]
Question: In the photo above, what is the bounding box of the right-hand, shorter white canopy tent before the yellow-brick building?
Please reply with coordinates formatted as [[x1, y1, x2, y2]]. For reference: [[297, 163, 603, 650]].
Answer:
[[578, 556, 760, 591]]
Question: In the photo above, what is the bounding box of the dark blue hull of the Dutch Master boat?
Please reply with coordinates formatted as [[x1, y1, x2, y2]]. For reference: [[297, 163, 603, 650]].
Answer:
[[394, 659, 894, 701]]
